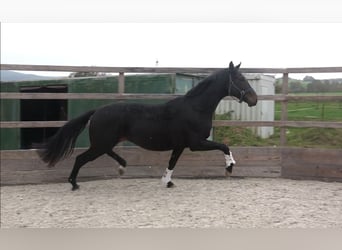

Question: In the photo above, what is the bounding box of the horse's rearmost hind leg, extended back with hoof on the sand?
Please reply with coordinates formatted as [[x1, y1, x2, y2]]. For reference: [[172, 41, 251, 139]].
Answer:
[[68, 148, 103, 191]]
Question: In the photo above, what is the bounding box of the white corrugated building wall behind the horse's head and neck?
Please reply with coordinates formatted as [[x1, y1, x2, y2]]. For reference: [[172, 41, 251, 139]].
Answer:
[[215, 74, 275, 138]]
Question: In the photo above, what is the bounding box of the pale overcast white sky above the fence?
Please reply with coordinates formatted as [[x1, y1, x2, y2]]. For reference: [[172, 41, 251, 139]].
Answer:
[[1, 17, 342, 77]]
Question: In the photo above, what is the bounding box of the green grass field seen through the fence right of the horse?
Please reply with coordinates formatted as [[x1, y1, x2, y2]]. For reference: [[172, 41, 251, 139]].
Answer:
[[214, 97, 342, 148]]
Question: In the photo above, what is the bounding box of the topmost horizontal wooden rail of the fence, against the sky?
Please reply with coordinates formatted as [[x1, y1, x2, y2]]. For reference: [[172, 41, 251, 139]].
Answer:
[[0, 64, 342, 74]]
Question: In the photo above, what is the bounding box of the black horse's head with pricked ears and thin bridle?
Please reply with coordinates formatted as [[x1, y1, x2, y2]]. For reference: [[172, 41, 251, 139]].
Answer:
[[228, 62, 258, 107]]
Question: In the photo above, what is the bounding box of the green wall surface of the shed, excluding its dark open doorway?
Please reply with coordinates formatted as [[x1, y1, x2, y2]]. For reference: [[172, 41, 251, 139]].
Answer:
[[0, 74, 202, 149]]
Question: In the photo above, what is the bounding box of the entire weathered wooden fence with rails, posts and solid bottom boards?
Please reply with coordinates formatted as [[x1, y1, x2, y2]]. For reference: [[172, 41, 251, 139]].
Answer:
[[0, 64, 342, 185]]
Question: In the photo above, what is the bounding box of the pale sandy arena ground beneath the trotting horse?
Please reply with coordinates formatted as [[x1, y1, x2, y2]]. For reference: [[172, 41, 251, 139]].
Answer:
[[1, 178, 342, 228]]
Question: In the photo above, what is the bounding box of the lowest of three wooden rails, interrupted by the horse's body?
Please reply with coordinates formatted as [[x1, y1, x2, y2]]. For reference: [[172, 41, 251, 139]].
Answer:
[[1, 120, 342, 128]]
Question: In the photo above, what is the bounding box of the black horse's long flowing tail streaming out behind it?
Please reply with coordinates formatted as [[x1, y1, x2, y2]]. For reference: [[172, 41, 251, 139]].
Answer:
[[37, 110, 96, 166]]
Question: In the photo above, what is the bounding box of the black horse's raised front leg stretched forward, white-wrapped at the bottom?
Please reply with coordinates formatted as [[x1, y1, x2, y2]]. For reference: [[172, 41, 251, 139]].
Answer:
[[190, 140, 236, 176]]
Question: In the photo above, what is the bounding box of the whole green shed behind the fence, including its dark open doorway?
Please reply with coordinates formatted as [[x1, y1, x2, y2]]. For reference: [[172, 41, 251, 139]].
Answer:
[[0, 74, 203, 150]]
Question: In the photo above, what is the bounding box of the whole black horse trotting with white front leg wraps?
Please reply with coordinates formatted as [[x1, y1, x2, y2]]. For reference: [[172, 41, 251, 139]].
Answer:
[[38, 62, 257, 190]]
